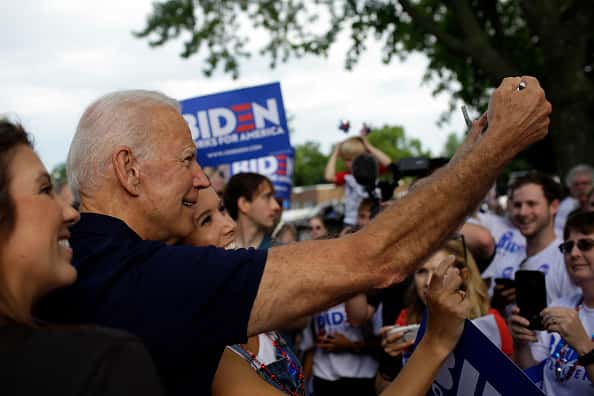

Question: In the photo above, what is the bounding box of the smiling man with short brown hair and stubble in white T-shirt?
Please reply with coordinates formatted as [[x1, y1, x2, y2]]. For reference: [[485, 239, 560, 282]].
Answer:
[[490, 172, 579, 311]]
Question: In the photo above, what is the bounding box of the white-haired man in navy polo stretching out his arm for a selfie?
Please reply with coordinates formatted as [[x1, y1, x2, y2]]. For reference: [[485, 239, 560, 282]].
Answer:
[[39, 77, 551, 395]]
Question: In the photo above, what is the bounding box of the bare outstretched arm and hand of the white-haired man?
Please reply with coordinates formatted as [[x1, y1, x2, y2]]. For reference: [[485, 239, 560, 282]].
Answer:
[[248, 77, 551, 335]]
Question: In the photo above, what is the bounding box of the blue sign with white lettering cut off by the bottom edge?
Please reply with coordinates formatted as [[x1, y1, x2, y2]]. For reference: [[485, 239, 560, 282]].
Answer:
[[417, 320, 544, 396]]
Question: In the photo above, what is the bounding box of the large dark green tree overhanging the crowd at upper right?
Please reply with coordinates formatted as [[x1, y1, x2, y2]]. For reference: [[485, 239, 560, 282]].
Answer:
[[136, 0, 594, 176]]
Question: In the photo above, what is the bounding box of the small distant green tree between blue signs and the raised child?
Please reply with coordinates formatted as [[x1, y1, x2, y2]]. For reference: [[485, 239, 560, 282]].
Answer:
[[293, 142, 328, 186]]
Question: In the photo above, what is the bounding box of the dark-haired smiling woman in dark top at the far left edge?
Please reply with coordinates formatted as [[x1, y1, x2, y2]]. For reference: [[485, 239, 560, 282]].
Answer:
[[0, 119, 162, 396]]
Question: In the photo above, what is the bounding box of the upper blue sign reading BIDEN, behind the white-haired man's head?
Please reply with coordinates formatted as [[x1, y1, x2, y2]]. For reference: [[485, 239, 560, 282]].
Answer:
[[180, 83, 291, 166]]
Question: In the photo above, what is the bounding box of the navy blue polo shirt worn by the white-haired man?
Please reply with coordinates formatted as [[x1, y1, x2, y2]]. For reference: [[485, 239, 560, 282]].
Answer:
[[36, 213, 266, 396]]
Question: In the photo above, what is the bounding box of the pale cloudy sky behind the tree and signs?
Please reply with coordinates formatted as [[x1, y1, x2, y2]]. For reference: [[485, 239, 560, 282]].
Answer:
[[0, 0, 464, 169]]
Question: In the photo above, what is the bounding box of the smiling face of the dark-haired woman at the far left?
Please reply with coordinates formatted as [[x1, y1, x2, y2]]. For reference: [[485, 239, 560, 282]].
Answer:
[[1, 145, 79, 298]]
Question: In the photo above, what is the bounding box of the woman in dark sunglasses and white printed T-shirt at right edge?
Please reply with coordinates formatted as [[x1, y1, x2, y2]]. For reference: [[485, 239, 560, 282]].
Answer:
[[510, 212, 594, 395]]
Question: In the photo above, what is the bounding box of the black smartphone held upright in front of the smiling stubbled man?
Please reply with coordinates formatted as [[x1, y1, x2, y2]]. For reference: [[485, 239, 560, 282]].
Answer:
[[515, 270, 547, 330]]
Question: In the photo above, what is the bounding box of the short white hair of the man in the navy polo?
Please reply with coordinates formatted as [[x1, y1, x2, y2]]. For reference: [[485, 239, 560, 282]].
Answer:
[[66, 90, 180, 202]]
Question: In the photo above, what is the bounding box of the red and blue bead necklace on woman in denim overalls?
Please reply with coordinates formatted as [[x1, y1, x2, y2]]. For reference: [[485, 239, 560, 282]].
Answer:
[[239, 333, 305, 396]]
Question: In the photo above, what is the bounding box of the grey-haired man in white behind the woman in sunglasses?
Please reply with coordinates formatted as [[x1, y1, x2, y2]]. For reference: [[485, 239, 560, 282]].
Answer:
[[555, 164, 594, 238]]
